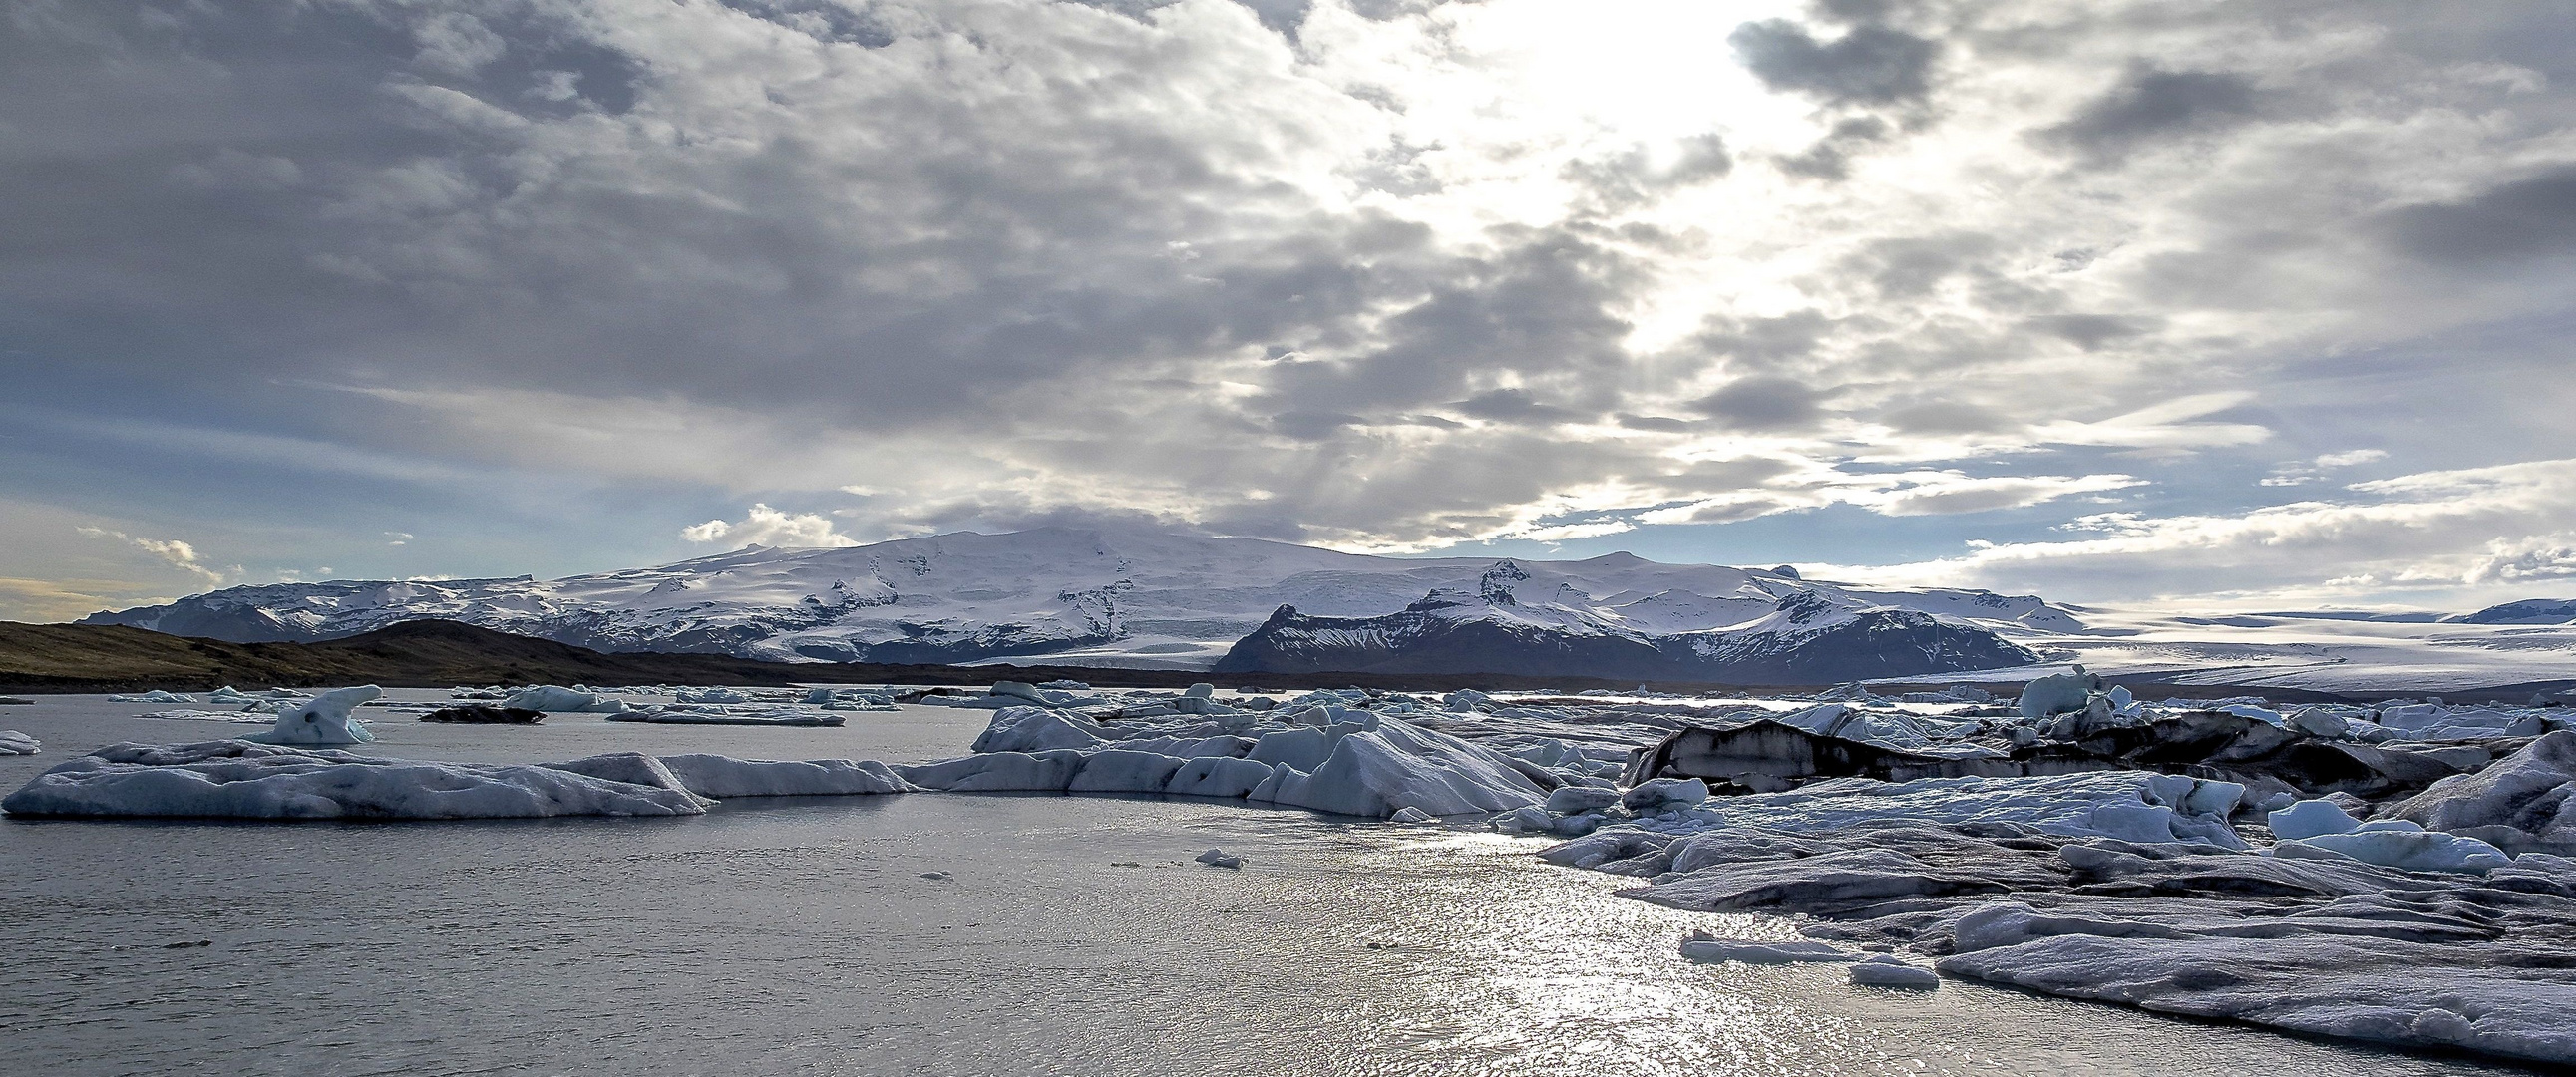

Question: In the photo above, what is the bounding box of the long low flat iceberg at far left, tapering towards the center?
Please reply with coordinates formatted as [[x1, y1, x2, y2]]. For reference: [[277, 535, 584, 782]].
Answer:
[[0, 740, 918, 820]]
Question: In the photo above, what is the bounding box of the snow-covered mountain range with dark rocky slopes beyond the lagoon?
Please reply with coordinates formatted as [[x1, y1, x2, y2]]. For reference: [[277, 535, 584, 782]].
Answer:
[[83, 529, 2084, 680]]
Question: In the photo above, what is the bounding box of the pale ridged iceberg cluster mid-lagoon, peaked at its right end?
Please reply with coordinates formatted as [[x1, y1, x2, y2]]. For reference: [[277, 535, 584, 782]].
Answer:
[[899, 693, 1566, 820]]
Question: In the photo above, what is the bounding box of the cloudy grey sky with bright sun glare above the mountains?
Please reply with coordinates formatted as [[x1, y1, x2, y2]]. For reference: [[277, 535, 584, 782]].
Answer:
[[0, 0, 2576, 621]]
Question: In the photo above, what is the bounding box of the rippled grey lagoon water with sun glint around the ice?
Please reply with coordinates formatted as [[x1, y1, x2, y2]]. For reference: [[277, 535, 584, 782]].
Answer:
[[0, 693, 2514, 1074]]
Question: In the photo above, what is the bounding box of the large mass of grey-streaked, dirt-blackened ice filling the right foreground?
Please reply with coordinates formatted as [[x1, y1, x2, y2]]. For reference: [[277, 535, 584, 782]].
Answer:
[[1492, 690, 2576, 1064]]
